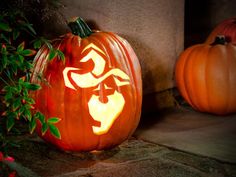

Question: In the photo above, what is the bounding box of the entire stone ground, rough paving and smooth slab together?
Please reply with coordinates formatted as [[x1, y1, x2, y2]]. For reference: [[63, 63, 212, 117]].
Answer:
[[2, 108, 236, 177]]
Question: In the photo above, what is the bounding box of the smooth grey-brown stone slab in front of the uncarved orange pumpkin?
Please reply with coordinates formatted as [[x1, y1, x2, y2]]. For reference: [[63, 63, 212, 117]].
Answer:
[[135, 107, 236, 163]]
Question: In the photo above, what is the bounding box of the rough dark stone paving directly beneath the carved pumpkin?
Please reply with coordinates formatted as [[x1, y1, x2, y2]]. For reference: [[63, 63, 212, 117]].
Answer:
[[1, 138, 236, 177]]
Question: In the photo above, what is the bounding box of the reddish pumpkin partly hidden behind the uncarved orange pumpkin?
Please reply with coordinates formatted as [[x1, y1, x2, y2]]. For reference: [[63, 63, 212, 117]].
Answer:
[[206, 17, 236, 44]]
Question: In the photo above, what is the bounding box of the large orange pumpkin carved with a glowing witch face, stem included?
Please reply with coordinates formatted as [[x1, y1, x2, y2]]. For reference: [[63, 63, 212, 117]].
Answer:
[[31, 18, 142, 151]]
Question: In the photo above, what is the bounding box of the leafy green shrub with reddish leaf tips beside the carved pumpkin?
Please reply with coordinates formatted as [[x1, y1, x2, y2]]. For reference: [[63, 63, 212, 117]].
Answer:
[[0, 8, 64, 156]]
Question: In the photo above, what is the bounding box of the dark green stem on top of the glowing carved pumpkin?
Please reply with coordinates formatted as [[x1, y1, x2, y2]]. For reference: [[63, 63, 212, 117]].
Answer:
[[68, 17, 93, 38]]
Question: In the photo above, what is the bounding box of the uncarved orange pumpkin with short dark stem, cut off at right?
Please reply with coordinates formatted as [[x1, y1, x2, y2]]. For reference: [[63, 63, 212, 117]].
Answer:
[[175, 38, 236, 115]]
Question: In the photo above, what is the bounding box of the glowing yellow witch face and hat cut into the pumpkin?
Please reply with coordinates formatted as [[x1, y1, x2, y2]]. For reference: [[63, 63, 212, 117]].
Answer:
[[63, 43, 130, 135]]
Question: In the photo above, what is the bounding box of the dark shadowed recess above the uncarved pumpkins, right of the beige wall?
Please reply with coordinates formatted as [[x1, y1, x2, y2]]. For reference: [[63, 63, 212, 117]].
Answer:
[[185, 0, 236, 48]]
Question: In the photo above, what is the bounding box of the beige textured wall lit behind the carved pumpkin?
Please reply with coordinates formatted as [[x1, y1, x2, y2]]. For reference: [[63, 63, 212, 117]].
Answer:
[[62, 0, 184, 94]]
